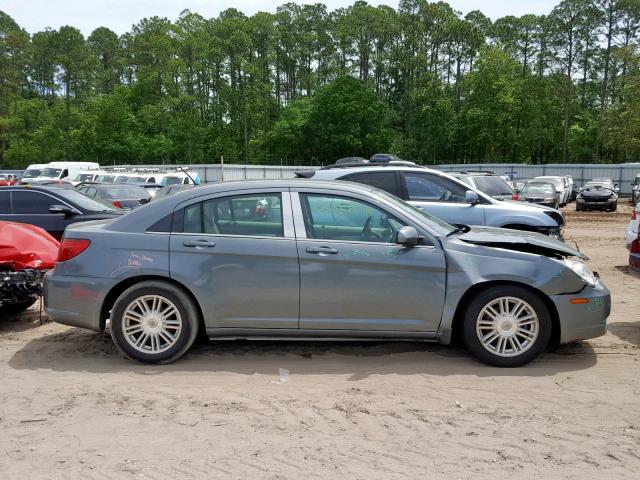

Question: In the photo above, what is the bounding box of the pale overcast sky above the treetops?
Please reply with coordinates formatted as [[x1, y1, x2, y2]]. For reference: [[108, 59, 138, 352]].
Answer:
[[0, 0, 559, 35]]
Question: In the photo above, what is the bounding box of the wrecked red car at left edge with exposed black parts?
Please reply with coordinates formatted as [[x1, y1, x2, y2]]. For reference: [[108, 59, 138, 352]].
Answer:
[[0, 221, 59, 315]]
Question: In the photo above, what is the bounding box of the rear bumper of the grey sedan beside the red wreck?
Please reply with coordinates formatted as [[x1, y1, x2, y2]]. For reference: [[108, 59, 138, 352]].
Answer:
[[43, 270, 115, 332]]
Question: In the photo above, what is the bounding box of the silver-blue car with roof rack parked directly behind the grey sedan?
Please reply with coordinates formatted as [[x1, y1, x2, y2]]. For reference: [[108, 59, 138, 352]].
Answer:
[[300, 164, 565, 238]]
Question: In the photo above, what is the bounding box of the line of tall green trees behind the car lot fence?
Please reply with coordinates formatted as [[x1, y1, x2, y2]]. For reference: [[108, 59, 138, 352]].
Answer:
[[0, 0, 640, 168]]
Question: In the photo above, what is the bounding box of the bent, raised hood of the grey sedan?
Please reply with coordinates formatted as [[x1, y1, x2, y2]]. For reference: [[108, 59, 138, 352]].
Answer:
[[458, 227, 588, 260]]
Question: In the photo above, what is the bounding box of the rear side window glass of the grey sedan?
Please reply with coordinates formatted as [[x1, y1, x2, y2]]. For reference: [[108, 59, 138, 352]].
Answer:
[[184, 193, 284, 237]]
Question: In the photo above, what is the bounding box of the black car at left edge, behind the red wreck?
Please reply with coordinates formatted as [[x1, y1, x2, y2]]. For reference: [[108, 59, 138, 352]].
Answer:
[[0, 186, 122, 240]]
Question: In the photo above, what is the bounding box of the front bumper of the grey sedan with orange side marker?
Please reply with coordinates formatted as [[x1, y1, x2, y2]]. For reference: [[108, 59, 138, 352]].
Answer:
[[550, 281, 611, 344]]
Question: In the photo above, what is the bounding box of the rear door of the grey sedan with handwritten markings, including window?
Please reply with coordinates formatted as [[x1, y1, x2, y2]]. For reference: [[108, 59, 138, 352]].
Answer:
[[170, 189, 300, 330]]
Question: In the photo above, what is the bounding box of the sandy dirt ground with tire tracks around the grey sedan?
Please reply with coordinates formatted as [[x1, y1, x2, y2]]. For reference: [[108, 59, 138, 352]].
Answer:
[[0, 205, 640, 479]]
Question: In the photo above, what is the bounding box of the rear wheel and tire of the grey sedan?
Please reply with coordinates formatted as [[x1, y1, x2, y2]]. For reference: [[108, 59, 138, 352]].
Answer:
[[111, 281, 200, 364]]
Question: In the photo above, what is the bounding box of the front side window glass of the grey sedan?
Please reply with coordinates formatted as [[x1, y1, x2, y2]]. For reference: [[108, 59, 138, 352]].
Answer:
[[300, 194, 405, 243]]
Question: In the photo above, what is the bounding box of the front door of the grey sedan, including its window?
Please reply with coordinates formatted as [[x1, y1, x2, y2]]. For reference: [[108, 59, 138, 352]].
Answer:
[[292, 191, 446, 332]]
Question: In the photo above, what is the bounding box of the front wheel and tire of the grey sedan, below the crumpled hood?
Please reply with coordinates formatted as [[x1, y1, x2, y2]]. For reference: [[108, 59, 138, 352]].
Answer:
[[462, 285, 552, 368]]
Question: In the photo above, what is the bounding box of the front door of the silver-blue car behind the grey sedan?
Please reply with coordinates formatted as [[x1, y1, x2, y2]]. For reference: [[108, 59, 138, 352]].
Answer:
[[401, 171, 485, 225]]
